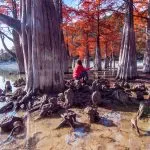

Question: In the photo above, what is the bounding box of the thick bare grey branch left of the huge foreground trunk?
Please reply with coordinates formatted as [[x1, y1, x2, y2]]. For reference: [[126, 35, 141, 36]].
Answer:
[[0, 13, 21, 34]]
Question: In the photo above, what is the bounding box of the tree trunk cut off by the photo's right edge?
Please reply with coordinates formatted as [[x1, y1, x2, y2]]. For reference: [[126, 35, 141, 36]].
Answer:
[[143, 0, 150, 73]]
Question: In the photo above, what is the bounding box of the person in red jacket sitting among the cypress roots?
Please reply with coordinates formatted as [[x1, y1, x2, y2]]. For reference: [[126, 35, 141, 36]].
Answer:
[[73, 60, 92, 81]]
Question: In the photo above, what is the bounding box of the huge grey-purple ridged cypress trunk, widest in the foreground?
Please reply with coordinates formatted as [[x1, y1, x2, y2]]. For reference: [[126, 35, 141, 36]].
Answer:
[[21, 0, 63, 92]]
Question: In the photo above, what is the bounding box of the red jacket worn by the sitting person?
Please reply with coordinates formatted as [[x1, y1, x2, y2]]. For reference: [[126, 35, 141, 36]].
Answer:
[[73, 65, 91, 78]]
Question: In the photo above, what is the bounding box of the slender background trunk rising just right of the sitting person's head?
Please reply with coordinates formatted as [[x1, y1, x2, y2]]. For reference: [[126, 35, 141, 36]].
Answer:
[[84, 33, 90, 68]]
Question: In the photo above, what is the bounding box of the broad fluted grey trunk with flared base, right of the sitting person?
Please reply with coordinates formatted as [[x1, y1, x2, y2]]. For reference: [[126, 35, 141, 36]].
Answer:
[[117, 0, 137, 80]]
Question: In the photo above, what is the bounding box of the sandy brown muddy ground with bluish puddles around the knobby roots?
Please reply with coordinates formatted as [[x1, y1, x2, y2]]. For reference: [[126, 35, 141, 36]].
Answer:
[[0, 74, 150, 150]]
